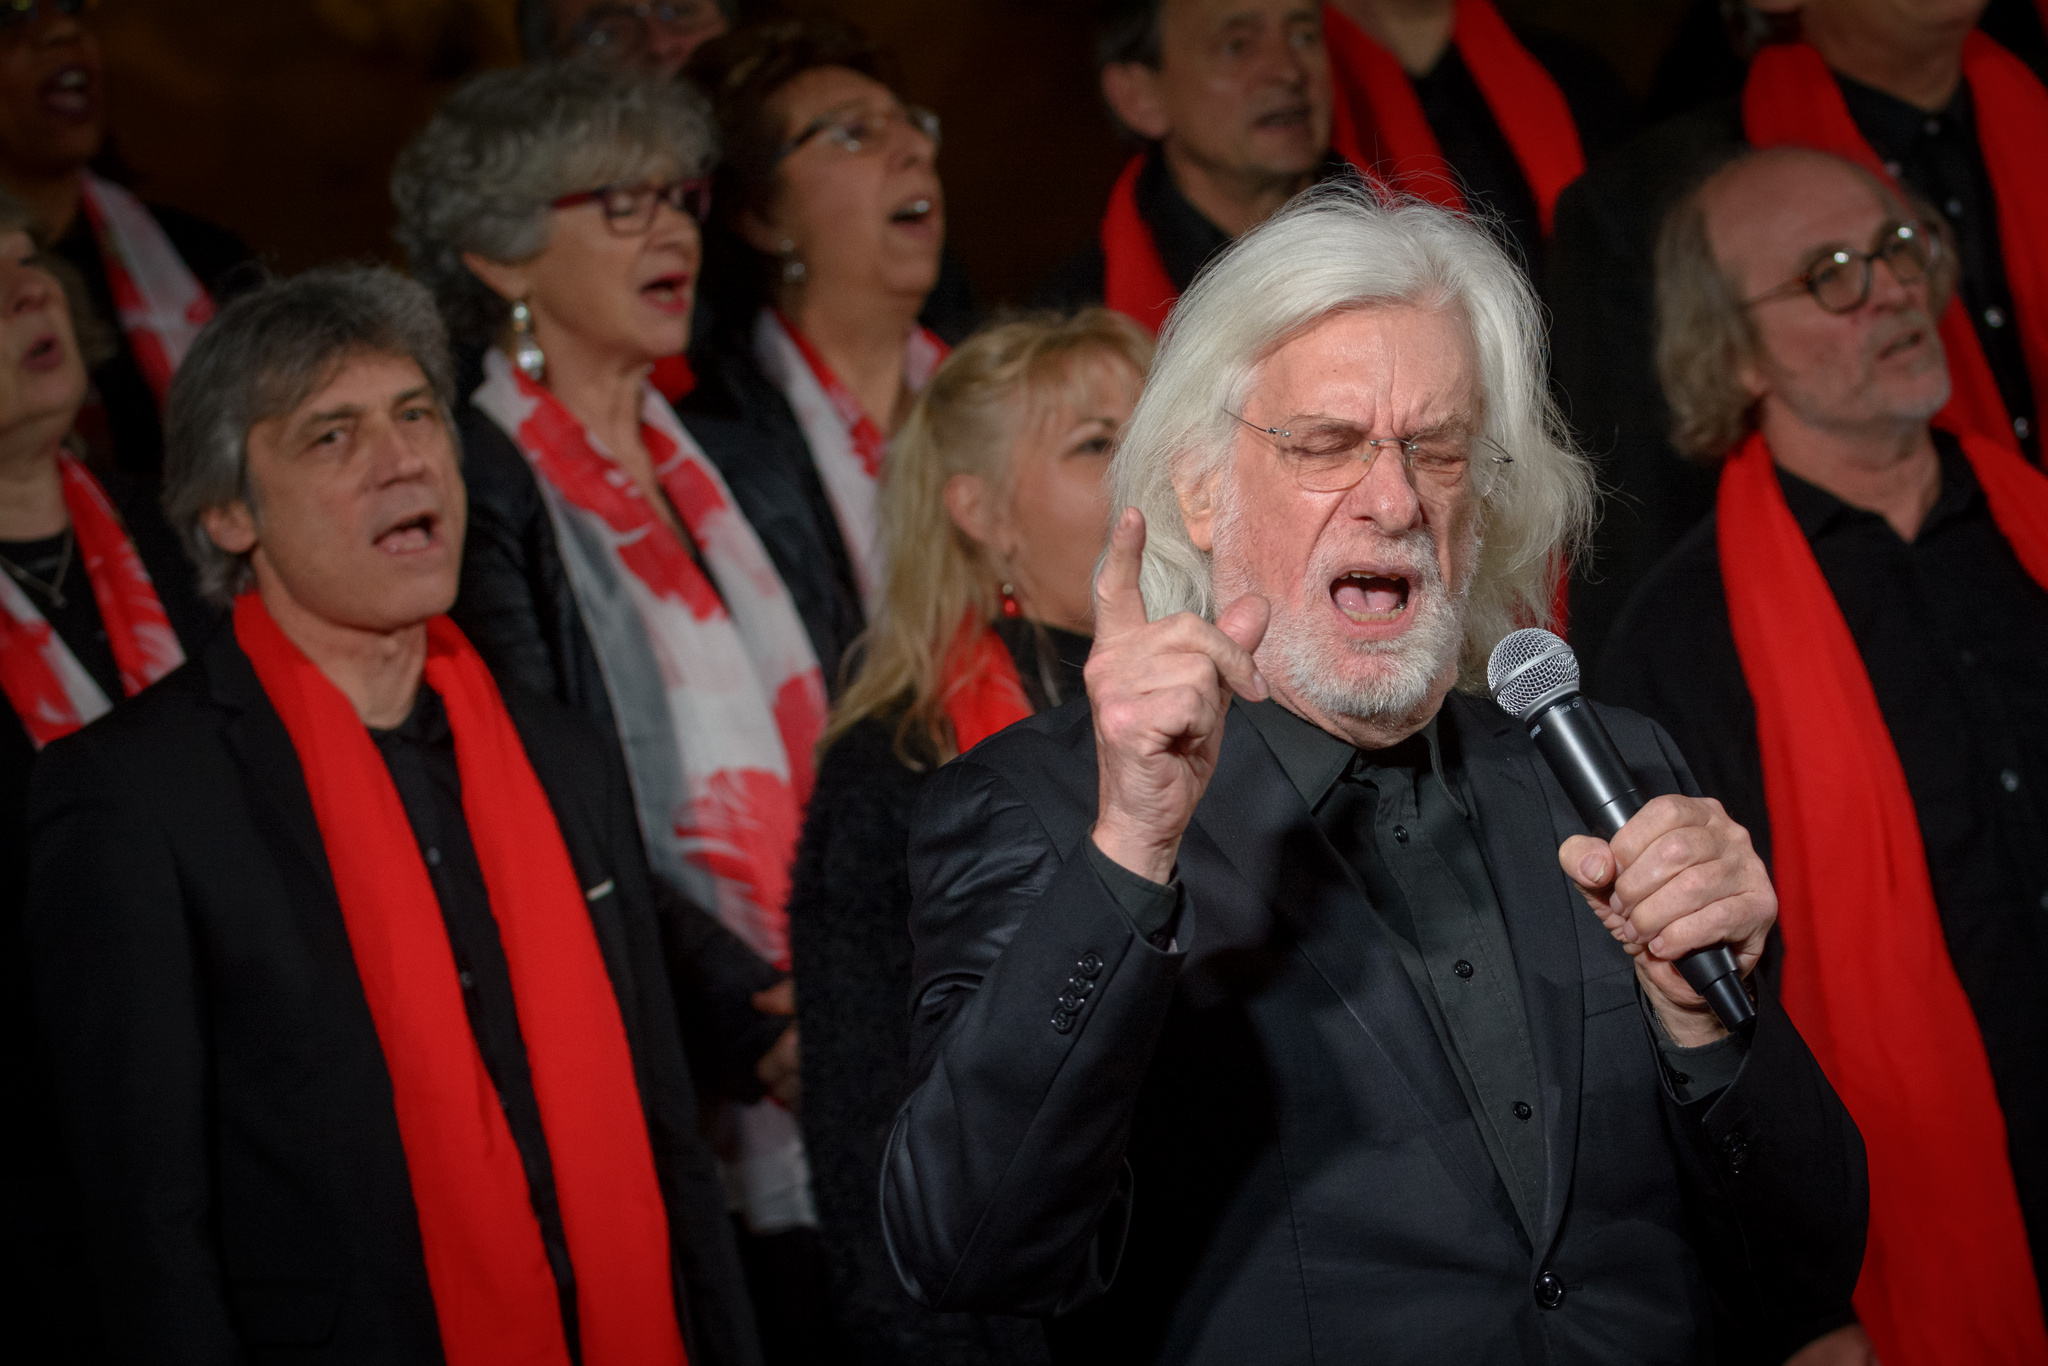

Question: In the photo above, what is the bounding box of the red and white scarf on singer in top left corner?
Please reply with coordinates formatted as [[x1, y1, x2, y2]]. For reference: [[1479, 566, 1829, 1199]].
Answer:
[[80, 174, 213, 405]]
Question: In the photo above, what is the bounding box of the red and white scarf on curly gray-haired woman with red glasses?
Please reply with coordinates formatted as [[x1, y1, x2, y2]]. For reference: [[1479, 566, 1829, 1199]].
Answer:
[[473, 350, 825, 1233]]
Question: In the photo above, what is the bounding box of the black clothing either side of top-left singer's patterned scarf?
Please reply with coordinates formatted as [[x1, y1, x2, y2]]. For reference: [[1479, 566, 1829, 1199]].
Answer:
[[49, 205, 260, 483]]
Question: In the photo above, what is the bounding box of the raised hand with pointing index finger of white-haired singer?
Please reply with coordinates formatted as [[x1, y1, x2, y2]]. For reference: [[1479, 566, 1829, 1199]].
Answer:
[[1087, 508, 1268, 883]]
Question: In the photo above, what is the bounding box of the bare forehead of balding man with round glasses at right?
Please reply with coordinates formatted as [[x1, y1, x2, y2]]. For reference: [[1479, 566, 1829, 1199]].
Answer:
[[1704, 152, 1905, 295]]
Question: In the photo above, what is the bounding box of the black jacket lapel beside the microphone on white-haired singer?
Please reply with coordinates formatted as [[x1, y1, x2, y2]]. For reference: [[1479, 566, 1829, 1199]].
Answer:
[[1446, 692, 1591, 1257]]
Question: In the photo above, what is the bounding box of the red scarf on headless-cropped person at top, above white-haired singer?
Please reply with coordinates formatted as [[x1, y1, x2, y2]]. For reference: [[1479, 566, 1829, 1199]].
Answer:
[[1323, 0, 1585, 233]]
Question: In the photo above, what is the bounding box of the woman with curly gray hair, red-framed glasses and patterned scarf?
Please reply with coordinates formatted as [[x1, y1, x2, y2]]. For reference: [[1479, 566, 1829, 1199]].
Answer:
[[391, 61, 825, 1359]]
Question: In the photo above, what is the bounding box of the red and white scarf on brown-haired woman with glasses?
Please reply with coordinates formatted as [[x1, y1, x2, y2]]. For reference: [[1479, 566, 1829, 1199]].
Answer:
[[754, 309, 950, 614]]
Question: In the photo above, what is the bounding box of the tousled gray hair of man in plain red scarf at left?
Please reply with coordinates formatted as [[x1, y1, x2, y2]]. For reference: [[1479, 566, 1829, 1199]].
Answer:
[[164, 266, 455, 604]]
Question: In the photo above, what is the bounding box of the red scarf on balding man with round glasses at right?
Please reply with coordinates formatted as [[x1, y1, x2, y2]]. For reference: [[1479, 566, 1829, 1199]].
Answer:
[[1718, 434, 2048, 1366]]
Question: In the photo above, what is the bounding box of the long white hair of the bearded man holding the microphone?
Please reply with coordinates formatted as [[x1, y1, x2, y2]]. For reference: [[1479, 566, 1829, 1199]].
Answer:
[[1110, 178, 1595, 688]]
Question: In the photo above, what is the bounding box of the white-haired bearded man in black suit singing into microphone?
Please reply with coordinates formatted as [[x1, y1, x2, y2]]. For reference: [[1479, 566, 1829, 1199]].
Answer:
[[883, 186, 1864, 1362]]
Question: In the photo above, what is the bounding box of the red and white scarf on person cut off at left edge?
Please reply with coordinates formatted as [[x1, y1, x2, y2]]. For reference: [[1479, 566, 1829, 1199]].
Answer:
[[0, 455, 184, 750]]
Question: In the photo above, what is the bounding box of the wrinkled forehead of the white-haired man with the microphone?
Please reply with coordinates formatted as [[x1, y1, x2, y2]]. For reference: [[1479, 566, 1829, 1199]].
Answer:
[[1251, 303, 1483, 436]]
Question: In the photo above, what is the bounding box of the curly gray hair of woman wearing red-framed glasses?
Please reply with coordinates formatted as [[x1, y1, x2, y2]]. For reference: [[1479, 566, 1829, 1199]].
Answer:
[[391, 59, 715, 346]]
